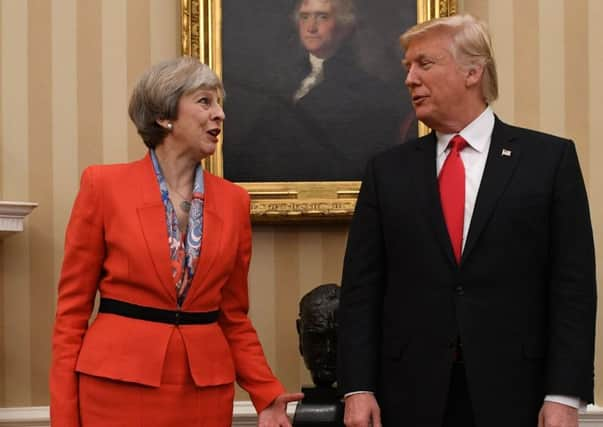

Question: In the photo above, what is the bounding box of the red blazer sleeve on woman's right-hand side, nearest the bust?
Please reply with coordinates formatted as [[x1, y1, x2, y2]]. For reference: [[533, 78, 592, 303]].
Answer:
[[219, 193, 285, 413]]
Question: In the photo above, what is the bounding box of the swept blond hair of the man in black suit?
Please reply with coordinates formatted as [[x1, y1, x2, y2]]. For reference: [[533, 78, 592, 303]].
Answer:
[[400, 14, 498, 103]]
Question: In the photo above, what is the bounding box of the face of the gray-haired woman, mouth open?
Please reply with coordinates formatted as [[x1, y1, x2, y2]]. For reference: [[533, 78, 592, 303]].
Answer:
[[170, 89, 225, 159]]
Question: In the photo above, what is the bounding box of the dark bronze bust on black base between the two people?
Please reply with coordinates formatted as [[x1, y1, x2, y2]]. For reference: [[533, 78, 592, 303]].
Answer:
[[293, 283, 343, 427]]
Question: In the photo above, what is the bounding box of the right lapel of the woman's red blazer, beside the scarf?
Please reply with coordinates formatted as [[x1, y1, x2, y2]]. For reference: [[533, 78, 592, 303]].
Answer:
[[183, 172, 223, 307]]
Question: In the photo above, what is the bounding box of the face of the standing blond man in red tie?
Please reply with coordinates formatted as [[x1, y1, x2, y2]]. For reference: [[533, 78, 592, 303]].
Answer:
[[403, 31, 475, 132]]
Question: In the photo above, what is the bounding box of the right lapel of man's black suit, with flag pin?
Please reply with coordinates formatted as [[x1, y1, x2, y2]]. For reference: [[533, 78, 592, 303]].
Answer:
[[461, 118, 520, 262]]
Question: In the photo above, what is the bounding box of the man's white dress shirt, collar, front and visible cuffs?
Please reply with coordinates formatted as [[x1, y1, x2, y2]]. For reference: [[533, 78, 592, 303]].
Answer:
[[345, 107, 586, 408]]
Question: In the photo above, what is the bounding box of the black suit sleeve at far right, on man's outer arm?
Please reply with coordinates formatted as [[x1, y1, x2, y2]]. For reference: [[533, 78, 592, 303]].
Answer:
[[546, 142, 597, 402]]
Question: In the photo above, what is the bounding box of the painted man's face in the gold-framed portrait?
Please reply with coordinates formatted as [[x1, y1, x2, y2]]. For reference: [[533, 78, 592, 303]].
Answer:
[[297, 0, 341, 58]]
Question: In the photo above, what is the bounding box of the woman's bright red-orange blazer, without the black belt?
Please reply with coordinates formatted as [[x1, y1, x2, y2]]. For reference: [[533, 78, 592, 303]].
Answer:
[[50, 155, 284, 427]]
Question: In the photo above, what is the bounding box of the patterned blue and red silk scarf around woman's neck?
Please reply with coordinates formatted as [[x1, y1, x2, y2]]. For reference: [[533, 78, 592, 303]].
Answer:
[[150, 149, 204, 307]]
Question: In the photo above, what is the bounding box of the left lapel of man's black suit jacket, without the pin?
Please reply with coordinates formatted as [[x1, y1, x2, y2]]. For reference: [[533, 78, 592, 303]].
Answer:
[[413, 132, 456, 265]]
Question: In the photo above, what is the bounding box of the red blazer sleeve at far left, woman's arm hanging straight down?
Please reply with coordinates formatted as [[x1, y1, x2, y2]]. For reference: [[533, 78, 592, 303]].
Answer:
[[50, 168, 105, 427]]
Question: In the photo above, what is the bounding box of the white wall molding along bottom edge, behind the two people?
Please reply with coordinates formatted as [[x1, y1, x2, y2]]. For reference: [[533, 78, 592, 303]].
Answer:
[[0, 400, 603, 427]]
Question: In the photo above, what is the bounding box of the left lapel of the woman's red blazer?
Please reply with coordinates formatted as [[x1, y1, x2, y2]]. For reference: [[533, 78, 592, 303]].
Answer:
[[138, 154, 176, 303]]
